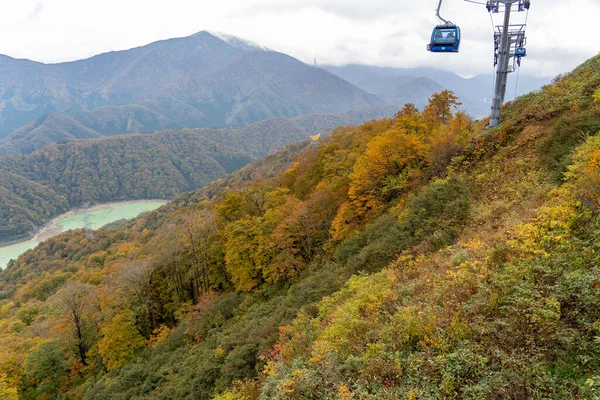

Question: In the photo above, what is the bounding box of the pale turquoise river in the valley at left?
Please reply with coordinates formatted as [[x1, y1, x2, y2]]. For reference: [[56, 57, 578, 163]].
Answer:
[[0, 200, 166, 269]]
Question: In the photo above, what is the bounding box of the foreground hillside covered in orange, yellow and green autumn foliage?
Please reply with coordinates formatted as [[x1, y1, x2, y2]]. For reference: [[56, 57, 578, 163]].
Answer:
[[0, 57, 600, 400]]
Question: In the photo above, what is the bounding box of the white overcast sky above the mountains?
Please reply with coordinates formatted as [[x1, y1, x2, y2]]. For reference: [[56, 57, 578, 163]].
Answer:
[[0, 0, 600, 76]]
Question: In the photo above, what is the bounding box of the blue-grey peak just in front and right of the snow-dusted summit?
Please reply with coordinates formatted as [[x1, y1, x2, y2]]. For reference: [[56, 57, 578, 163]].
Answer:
[[145, 51, 385, 128]]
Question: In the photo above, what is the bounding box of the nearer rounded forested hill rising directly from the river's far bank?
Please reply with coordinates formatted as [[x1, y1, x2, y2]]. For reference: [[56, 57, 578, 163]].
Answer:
[[0, 131, 246, 241]]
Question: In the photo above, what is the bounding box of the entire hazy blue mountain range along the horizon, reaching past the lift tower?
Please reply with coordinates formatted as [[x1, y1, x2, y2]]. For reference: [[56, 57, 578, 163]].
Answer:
[[0, 31, 549, 156]]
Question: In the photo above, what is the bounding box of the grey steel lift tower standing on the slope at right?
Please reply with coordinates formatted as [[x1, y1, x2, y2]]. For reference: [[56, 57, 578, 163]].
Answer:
[[486, 0, 530, 128]]
